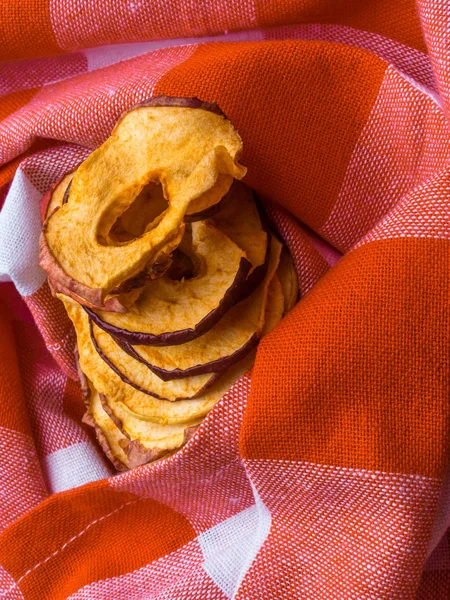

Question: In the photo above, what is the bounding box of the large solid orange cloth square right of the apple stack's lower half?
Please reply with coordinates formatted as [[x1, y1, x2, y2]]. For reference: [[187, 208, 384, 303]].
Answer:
[[241, 239, 450, 477]]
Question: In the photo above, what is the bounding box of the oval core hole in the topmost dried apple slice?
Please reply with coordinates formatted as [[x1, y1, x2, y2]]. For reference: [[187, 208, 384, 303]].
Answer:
[[108, 181, 169, 244]]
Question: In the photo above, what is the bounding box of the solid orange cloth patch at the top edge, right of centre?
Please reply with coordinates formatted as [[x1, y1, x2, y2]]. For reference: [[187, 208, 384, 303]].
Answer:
[[256, 0, 426, 52]]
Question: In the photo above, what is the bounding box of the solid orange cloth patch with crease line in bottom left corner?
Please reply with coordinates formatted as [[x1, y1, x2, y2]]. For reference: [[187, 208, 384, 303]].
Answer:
[[0, 483, 195, 600]]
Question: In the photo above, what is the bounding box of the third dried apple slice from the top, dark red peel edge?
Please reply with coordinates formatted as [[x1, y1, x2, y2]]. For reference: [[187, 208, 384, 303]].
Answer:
[[121, 237, 284, 381]]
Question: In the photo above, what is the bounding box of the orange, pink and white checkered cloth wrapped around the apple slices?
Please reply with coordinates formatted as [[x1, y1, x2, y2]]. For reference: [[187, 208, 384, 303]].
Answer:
[[0, 0, 450, 600]]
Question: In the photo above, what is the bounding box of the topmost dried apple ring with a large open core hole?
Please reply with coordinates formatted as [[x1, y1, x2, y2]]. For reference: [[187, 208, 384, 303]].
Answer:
[[40, 98, 246, 306]]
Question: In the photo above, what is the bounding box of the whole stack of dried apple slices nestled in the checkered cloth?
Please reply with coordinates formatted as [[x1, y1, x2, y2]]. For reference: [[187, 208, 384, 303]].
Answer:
[[40, 97, 298, 470]]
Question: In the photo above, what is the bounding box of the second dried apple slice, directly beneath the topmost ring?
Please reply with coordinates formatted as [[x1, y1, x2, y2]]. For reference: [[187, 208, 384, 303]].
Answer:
[[85, 221, 251, 346]]
